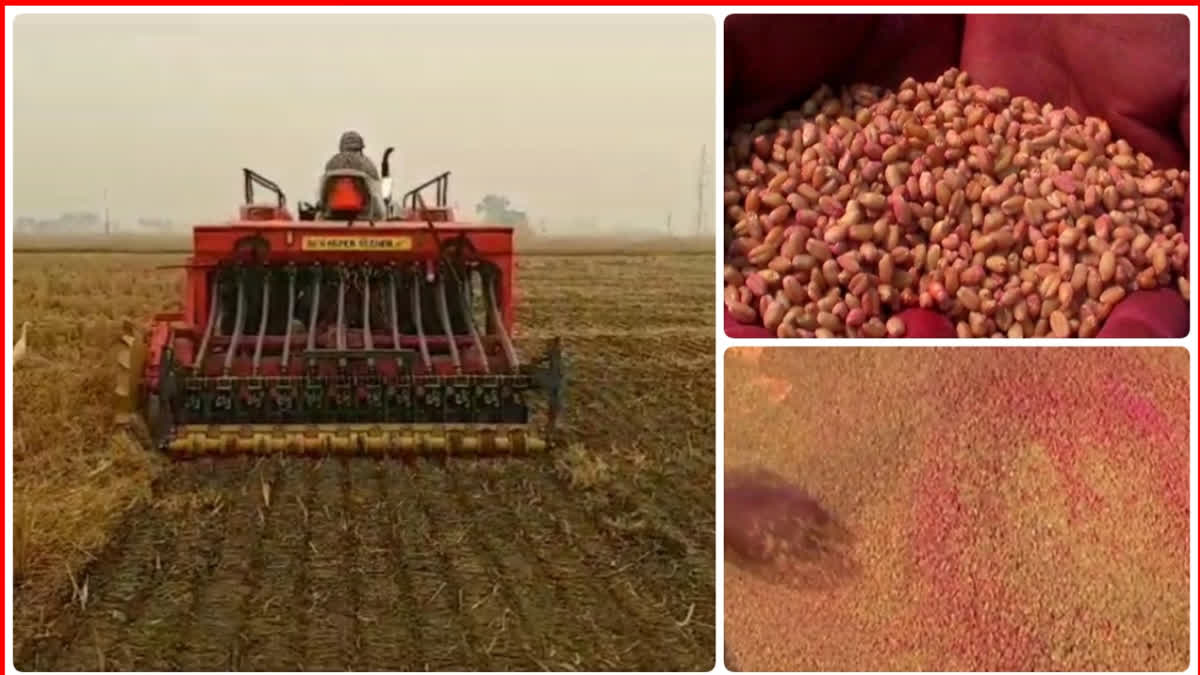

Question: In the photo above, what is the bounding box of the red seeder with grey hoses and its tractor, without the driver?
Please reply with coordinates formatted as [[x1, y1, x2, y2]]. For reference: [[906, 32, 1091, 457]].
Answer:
[[116, 148, 566, 456]]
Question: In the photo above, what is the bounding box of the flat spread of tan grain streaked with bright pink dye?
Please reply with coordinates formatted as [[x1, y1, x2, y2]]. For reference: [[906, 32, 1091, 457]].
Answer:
[[725, 348, 1190, 671]]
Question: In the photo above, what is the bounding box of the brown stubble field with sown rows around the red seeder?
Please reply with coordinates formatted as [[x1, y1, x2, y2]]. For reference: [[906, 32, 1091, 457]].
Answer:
[[13, 253, 715, 670]]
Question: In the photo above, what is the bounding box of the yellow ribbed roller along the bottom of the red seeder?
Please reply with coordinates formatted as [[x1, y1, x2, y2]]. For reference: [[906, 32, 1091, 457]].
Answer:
[[166, 424, 546, 456]]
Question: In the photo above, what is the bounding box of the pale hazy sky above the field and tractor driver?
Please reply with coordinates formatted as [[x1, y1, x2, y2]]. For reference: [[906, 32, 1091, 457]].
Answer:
[[13, 14, 715, 233]]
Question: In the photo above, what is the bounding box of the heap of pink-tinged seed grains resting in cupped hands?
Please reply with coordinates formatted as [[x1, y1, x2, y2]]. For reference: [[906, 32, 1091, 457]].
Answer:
[[725, 70, 1189, 338]]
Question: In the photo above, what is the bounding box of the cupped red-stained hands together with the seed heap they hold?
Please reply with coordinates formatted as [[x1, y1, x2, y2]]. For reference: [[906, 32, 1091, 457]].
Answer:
[[725, 16, 1189, 338]]
